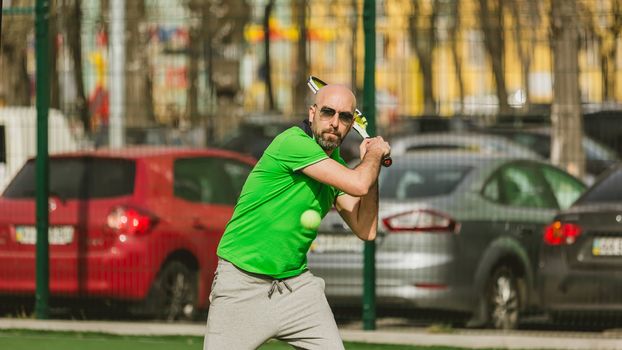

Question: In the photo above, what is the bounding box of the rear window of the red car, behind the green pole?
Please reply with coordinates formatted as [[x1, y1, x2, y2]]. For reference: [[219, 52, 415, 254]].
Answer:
[[3, 157, 136, 200]]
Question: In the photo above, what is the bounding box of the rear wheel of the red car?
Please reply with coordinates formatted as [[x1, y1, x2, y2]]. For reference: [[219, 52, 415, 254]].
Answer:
[[147, 261, 198, 321]]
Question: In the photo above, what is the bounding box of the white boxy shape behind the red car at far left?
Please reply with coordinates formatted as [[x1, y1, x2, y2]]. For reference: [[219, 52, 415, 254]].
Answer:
[[0, 107, 79, 193]]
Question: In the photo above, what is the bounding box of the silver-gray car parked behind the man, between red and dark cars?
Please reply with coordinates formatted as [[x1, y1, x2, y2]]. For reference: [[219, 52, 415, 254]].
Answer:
[[308, 151, 585, 329]]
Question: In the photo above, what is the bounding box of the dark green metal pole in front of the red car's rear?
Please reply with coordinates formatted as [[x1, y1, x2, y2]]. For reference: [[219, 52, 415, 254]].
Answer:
[[35, 0, 50, 319]]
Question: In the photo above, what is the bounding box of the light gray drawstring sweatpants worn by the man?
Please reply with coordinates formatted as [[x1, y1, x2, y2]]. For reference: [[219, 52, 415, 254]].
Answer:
[[203, 259, 344, 350]]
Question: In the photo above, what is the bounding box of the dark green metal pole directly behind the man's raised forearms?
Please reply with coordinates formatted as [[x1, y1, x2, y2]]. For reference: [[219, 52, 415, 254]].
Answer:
[[363, 0, 376, 330]]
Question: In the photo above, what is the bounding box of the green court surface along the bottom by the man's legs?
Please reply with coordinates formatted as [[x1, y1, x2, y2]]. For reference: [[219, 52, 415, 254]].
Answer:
[[0, 330, 468, 350]]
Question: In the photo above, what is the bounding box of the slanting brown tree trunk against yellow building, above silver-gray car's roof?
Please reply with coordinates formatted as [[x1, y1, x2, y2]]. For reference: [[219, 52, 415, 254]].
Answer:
[[479, 0, 510, 114]]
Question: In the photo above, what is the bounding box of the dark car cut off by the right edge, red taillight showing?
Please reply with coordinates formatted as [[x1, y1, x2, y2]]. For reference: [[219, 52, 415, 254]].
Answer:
[[539, 164, 622, 318]]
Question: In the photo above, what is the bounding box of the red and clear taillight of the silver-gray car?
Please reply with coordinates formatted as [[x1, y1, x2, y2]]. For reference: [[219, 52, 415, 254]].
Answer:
[[382, 209, 459, 233]]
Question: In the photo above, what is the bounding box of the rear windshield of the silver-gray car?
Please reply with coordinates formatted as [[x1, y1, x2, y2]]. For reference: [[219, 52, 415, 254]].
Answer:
[[380, 163, 471, 199]]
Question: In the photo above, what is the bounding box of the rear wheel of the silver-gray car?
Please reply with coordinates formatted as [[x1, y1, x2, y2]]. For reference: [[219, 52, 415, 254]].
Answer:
[[486, 266, 520, 329]]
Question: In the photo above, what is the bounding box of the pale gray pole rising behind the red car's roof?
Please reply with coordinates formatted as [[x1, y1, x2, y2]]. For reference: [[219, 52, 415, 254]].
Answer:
[[108, 0, 125, 148]]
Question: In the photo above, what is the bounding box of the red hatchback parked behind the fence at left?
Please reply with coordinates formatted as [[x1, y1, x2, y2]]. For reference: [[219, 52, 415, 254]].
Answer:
[[0, 148, 255, 320]]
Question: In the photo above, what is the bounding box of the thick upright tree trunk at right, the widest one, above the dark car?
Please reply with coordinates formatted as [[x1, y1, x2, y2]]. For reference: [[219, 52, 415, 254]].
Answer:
[[551, 0, 585, 177]]
